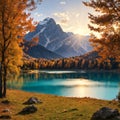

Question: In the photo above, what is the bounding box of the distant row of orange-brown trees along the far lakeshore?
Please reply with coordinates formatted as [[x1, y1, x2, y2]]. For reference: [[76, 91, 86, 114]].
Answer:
[[22, 52, 120, 70]]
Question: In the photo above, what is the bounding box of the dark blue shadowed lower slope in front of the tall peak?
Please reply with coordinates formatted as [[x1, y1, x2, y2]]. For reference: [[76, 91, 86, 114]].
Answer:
[[25, 44, 62, 59]]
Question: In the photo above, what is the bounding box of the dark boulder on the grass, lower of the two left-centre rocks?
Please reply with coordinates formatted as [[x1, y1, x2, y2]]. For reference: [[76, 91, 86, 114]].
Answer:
[[19, 105, 37, 115]]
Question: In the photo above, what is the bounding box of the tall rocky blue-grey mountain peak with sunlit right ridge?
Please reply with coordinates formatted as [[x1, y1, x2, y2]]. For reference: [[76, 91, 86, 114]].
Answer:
[[25, 18, 92, 57]]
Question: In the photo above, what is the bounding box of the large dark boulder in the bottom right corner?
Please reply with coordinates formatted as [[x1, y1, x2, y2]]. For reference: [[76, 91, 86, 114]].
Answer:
[[91, 107, 120, 120]]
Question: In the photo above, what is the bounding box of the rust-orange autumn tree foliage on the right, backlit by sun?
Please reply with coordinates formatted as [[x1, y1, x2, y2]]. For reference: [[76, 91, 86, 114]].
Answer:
[[83, 0, 120, 62]]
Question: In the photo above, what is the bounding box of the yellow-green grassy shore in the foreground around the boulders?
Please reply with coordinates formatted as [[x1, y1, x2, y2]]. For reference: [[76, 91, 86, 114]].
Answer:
[[0, 90, 120, 120]]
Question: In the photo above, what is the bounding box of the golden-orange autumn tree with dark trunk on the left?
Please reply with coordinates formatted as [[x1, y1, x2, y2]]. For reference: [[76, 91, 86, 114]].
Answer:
[[0, 0, 41, 98]]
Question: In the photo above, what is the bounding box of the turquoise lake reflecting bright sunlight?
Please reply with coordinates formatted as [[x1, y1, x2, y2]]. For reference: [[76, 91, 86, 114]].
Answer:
[[7, 70, 120, 100]]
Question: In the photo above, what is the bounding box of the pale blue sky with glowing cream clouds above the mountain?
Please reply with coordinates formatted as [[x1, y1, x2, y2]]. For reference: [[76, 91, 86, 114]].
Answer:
[[32, 0, 93, 35]]
